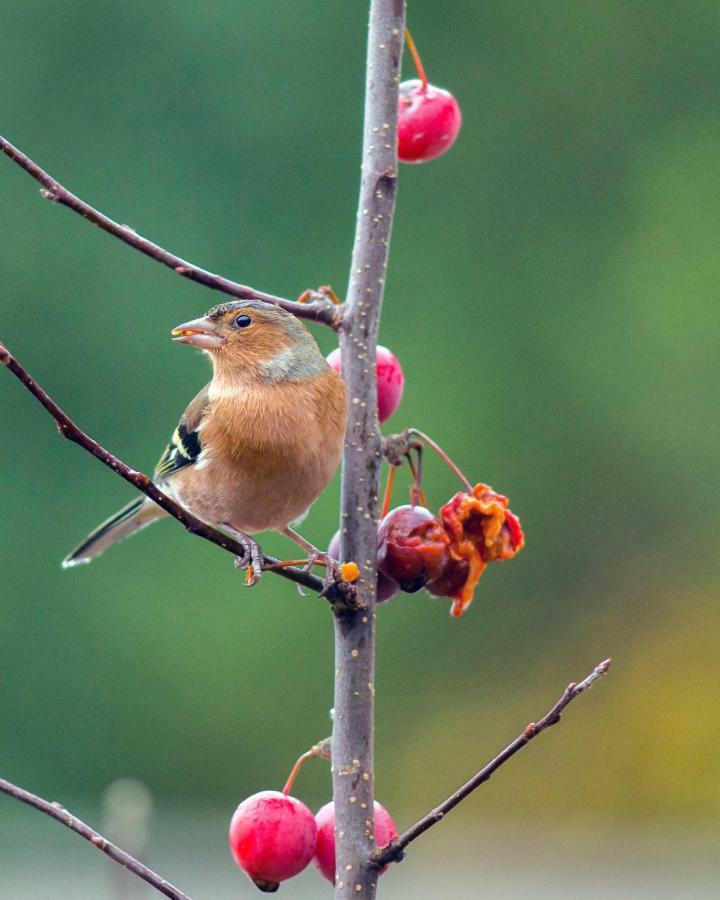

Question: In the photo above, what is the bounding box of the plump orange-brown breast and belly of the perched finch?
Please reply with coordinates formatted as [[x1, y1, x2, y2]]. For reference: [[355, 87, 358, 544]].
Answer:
[[173, 370, 347, 533]]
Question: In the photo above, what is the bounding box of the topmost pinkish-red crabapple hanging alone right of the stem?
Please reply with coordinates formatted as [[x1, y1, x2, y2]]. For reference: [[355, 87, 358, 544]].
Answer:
[[398, 78, 462, 163]]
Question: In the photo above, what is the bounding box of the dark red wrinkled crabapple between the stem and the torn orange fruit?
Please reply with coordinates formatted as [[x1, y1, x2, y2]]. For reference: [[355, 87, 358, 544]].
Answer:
[[378, 506, 450, 594]]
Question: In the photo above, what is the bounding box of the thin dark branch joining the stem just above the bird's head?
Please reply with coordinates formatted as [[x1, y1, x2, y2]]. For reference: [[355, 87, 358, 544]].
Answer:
[[0, 135, 342, 329]]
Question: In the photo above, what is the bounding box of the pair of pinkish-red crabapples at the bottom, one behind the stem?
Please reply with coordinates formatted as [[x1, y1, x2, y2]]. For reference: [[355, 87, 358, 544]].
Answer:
[[229, 791, 397, 893]]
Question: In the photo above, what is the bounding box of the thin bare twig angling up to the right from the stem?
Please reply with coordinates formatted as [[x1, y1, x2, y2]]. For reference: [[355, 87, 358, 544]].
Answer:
[[373, 659, 611, 868]]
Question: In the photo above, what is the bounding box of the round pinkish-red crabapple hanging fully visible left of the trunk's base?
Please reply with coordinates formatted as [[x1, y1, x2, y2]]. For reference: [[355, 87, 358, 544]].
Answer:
[[228, 791, 317, 893]]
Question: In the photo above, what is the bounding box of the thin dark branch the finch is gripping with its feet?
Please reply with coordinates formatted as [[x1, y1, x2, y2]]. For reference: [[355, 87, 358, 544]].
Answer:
[[0, 341, 355, 604]]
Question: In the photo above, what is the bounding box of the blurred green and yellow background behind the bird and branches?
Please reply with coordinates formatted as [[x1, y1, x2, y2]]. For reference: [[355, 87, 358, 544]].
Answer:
[[0, 0, 720, 900]]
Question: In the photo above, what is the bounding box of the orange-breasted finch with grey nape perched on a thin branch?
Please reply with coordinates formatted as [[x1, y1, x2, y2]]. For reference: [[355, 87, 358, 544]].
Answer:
[[63, 300, 347, 576]]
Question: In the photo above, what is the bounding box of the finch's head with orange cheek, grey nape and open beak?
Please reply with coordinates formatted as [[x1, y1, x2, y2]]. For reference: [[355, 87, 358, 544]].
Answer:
[[172, 300, 327, 381]]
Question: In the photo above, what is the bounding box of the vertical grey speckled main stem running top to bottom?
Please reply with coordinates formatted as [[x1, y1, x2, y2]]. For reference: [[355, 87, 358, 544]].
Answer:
[[332, 0, 405, 900]]
